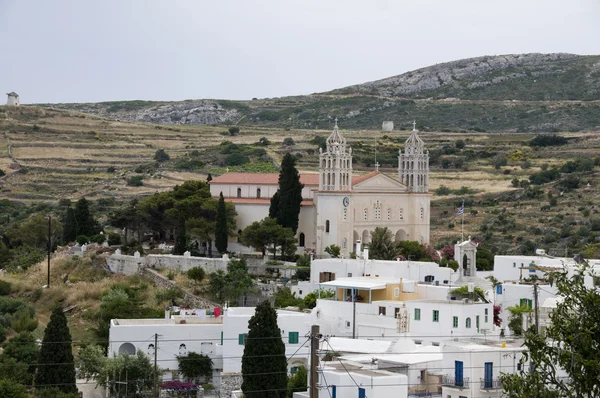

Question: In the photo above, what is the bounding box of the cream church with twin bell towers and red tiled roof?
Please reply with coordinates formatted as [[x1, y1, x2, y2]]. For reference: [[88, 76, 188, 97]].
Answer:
[[210, 120, 431, 257]]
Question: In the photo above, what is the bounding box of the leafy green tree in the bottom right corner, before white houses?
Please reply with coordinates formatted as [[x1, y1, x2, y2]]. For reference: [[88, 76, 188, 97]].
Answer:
[[502, 263, 600, 398]]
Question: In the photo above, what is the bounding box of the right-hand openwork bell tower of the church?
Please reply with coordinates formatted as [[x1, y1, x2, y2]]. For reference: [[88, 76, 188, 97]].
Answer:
[[398, 122, 429, 192]]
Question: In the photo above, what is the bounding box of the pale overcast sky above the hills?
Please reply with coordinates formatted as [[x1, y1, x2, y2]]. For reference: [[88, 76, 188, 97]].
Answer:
[[0, 0, 600, 103]]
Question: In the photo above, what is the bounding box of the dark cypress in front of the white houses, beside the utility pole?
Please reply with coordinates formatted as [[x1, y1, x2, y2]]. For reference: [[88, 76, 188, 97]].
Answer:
[[242, 301, 288, 398]]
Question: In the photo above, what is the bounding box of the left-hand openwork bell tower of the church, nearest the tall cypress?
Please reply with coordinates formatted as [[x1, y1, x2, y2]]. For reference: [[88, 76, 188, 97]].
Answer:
[[319, 118, 352, 191]]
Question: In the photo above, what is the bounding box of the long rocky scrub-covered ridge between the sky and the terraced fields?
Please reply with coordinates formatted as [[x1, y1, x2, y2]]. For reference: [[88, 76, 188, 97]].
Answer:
[[39, 54, 600, 132]]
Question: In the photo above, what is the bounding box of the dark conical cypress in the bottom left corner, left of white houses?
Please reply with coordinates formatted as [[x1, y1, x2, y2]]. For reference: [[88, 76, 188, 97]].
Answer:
[[35, 306, 77, 393]]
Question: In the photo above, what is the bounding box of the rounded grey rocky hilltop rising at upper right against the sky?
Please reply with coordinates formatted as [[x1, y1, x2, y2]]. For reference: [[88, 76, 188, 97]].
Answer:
[[330, 53, 600, 101]]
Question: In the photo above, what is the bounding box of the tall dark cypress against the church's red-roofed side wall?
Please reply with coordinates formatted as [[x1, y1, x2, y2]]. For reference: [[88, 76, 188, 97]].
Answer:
[[277, 153, 304, 234]]
